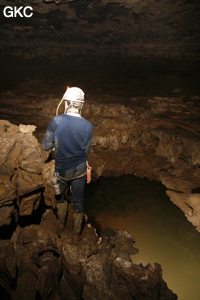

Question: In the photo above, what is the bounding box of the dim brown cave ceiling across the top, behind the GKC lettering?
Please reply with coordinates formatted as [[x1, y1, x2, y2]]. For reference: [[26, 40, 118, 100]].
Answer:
[[0, 0, 200, 60]]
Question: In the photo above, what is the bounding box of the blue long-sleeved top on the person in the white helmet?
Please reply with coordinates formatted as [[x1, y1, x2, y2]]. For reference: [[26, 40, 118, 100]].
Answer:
[[42, 114, 93, 172]]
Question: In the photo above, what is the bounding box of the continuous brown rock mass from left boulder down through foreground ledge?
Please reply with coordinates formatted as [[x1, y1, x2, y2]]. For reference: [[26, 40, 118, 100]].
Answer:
[[0, 121, 177, 300]]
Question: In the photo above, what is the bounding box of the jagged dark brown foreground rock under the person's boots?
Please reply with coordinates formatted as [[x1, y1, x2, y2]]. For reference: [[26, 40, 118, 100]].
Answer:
[[0, 209, 177, 300]]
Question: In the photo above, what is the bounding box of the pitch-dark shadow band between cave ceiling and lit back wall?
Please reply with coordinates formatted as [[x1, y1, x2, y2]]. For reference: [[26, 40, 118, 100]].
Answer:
[[0, 56, 200, 102]]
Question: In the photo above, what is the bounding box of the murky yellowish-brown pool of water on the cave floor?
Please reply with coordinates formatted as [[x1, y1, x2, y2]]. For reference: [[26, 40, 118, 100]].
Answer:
[[85, 176, 200, 300]]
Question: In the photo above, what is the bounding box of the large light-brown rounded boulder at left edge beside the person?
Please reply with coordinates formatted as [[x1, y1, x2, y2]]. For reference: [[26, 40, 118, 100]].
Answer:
[[0, 120, 44, 225]]
